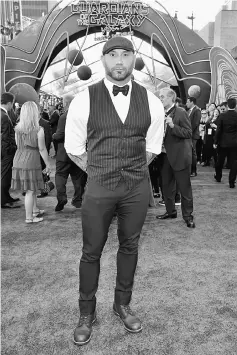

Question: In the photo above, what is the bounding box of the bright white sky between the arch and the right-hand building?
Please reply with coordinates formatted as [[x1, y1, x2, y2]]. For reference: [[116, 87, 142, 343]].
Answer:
[[58, 0, 226, 30]]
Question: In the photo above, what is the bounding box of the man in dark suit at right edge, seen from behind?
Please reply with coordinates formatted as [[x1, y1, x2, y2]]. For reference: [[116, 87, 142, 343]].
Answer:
[[214, 98, 237, 188]]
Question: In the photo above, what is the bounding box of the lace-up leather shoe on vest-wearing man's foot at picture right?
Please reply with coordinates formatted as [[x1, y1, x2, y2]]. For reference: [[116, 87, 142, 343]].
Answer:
[[113, 303, 142, 333]]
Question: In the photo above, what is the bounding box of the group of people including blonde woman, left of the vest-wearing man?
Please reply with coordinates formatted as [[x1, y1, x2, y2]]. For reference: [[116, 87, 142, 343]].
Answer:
[[1, 92, 87, 223]]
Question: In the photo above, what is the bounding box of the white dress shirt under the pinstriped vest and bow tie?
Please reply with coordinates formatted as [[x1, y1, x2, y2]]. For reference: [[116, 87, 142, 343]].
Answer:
[[64, 79, 165, 156]]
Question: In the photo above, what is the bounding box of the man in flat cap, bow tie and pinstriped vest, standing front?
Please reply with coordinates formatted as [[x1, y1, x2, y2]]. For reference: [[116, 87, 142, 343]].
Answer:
[[65, 37, 164, 345]]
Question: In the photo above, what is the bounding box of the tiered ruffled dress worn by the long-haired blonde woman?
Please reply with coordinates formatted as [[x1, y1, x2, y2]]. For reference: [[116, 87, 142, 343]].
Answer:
[[12, 128, 44, 191]]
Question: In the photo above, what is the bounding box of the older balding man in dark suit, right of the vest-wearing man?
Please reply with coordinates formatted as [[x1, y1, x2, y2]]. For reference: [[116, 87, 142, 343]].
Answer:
[[156, 88, 195, 228]]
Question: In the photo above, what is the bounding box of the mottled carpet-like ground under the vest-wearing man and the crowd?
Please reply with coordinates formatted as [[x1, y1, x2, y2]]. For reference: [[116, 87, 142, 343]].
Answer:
[[1, 167, 237, 355]]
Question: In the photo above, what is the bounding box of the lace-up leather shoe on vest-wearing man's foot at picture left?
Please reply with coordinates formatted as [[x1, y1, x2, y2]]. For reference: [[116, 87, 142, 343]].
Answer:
[[74, 312, 96, 346]]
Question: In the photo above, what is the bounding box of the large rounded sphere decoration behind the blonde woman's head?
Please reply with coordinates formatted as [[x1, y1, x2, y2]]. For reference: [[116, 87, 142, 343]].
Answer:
[[9, 83, 39, 105]]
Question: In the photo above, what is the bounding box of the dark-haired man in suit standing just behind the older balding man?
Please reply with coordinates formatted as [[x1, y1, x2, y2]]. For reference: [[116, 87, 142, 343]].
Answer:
[[186, 97, 201, 177]]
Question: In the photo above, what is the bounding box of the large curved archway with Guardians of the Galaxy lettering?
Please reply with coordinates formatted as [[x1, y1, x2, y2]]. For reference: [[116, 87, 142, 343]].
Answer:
[[6, 1, 211, 106]]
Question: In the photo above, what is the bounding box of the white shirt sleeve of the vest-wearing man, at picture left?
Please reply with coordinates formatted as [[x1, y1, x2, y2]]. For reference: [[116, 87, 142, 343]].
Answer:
[[64, 88, 90, 156]]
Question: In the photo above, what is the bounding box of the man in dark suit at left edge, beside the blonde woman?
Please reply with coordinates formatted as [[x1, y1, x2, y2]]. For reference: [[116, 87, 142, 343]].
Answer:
[[1, 92, 20, 208]]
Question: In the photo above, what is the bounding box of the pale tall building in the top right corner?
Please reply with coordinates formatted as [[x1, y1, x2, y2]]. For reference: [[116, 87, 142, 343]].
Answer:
[[198, 0, 237, 52]]
